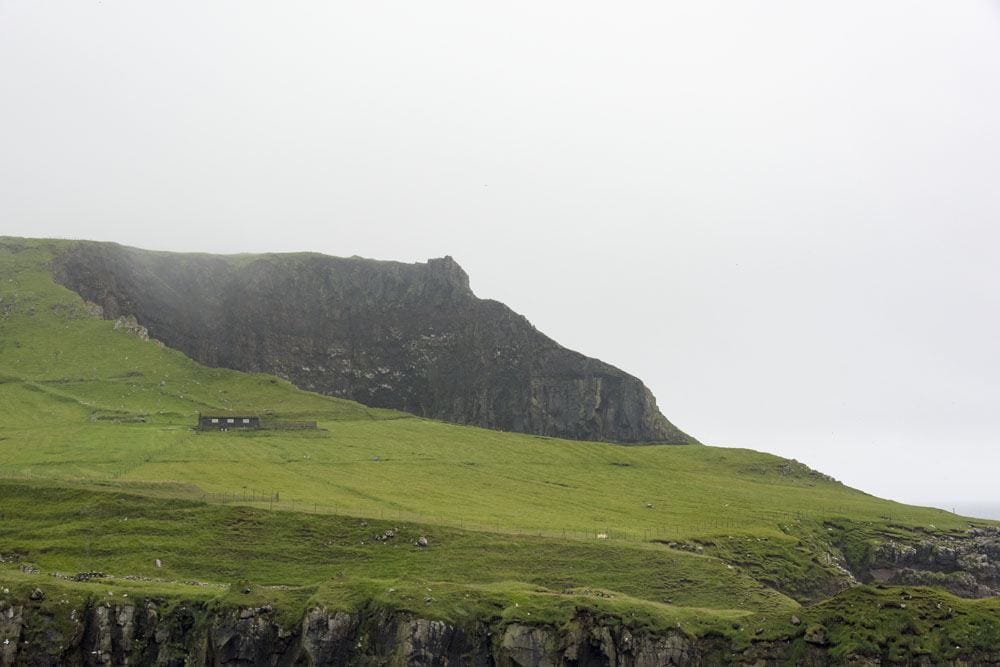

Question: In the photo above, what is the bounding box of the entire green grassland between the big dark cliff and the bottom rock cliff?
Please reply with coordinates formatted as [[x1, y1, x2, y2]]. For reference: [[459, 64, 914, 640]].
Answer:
[[0, 238, 996, 656]]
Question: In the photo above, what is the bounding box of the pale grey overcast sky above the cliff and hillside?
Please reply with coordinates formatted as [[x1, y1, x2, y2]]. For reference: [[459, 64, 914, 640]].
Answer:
[[0, 0, 1000, 511]]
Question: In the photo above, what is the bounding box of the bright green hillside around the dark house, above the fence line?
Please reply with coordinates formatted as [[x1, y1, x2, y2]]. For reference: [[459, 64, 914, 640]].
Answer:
[[0, 240, 965, 536]]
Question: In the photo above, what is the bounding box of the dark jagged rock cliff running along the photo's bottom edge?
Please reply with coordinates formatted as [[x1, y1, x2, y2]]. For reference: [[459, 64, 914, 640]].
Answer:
[[0, 601, 1000, 667]]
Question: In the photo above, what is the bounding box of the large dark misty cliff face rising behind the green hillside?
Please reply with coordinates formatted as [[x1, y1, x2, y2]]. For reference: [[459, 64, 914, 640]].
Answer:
[[53, 242, 695, 443]]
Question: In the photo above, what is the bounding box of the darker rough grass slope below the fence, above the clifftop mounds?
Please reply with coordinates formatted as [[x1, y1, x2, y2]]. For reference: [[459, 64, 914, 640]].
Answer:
[[0, 482, 798, 617]]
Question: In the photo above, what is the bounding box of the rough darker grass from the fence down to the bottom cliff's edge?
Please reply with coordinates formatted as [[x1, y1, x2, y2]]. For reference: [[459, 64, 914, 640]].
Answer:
[[0, 482, 1000, 662]]
